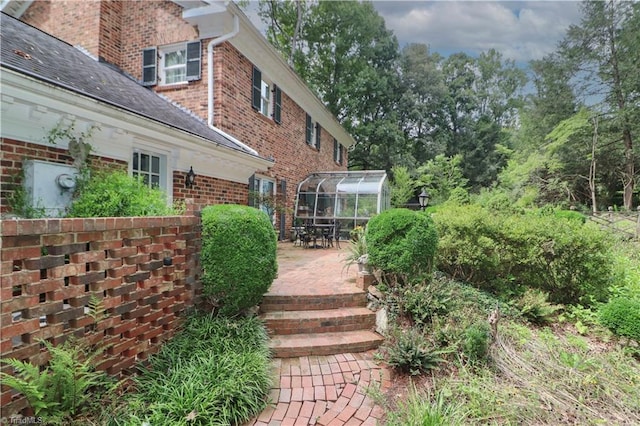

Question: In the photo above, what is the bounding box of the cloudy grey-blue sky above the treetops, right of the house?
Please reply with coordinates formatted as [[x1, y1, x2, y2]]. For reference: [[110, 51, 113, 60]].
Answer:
[[374, 1, 580, 61]]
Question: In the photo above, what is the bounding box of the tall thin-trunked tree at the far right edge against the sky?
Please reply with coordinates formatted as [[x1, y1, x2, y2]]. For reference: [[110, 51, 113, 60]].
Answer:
[[560, 0, 640, 209]]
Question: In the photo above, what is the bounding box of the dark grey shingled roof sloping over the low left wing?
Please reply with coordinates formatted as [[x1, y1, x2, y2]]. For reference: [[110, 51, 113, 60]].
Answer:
[[0, 13, 260, 155]]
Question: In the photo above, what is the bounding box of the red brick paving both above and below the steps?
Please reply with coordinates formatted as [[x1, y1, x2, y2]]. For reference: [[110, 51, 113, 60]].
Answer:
[[245, 243, 390, 426]]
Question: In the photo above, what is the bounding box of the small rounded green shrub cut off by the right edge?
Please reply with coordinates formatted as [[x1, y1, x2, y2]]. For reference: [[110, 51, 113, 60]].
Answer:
[[600, 298, 640, 343]]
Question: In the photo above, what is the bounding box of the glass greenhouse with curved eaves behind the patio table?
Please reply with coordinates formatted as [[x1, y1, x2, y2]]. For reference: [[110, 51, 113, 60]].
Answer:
[[294, 170, 391, 230]]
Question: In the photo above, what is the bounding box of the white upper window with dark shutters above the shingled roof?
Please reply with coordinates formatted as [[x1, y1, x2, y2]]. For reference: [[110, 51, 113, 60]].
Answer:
[[142, 41, 202, 86]]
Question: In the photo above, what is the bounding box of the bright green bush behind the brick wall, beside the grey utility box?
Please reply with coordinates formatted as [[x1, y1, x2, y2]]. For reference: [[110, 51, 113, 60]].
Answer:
[[67, 171, 175, 217]]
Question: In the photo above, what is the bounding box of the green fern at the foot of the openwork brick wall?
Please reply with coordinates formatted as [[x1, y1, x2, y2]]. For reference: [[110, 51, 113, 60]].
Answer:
[[0, 340, 111, 424]]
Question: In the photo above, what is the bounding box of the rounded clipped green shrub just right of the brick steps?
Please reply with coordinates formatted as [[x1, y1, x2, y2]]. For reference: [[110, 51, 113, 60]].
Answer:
[[366, 209, 438, 283]]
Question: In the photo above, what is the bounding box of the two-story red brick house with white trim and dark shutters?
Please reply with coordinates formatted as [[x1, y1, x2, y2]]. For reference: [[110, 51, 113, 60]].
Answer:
[[2, 0, 354, 235]]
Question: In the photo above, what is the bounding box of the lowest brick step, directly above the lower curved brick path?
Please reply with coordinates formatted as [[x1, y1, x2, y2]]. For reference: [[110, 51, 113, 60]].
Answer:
[[269, 330, 383, 358]]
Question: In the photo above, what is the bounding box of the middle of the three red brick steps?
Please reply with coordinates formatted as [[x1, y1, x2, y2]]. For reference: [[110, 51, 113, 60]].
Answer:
[[262, 307, 376, 335]]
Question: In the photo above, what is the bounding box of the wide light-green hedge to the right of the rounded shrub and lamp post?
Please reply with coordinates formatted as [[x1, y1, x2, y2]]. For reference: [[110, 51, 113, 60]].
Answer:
[[433, 205, 613, 304]]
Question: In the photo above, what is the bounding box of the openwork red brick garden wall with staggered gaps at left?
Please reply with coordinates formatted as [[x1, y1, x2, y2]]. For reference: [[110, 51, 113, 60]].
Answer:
[[0, 216, 201, 416]]
